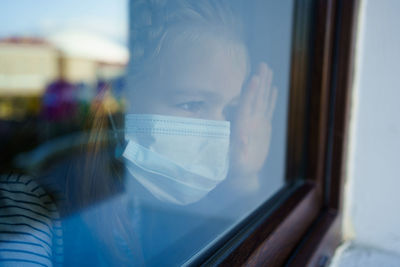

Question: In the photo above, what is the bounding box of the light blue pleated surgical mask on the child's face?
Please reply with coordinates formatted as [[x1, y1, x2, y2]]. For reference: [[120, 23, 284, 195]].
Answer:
[[123, 114, 230, 205]]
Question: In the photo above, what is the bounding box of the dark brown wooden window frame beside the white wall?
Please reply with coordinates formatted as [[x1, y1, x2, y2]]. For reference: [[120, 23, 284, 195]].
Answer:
[[191, 0, 359, 266]]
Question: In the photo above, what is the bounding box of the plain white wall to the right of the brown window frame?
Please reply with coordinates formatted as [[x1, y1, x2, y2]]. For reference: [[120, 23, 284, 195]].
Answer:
[[345, 0, 400, 254]]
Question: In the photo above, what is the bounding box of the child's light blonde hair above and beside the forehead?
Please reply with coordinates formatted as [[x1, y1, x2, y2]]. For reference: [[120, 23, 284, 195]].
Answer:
[[127, 0, 244, 84]]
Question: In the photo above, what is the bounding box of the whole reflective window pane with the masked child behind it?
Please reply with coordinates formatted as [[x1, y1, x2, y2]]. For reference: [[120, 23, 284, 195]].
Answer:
[[0, 0, 294, 266]]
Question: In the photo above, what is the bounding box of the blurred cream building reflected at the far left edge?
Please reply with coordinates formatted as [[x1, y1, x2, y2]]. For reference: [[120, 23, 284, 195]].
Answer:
[[0, 38, 60, 120]]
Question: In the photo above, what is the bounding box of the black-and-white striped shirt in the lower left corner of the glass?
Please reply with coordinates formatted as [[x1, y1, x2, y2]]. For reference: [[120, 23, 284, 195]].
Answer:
[[0, 174, 63, 266]]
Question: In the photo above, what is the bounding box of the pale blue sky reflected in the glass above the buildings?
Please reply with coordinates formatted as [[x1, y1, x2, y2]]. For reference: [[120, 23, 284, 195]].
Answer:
[[0, 0, 129, 44]]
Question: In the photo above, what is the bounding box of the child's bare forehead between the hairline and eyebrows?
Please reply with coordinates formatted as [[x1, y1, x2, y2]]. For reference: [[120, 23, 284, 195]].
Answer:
[[160, 36, 248, 96]]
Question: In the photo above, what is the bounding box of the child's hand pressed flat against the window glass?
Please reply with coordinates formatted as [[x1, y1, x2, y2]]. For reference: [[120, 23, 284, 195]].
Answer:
[[230, 63, 278, 191]]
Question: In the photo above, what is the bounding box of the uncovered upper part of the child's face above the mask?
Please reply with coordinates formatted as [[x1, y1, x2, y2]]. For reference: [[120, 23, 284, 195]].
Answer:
[[128, 34, 247, 120]]
